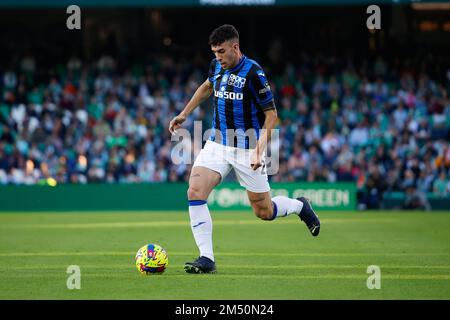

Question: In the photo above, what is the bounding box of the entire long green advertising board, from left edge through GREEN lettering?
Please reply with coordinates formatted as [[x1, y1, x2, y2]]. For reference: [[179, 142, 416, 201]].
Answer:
[[0, 182, 356, 212]]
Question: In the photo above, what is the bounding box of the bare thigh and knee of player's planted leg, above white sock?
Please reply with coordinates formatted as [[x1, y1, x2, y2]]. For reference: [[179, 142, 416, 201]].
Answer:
[[188, 166, 221, 200]]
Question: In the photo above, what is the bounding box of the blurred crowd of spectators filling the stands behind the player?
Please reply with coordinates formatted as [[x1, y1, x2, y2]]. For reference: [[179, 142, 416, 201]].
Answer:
[[0, 53, 450, 208]]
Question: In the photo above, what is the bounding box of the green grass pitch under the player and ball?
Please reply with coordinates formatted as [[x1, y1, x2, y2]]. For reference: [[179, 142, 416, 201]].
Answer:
[[0, 212, 450, 300]]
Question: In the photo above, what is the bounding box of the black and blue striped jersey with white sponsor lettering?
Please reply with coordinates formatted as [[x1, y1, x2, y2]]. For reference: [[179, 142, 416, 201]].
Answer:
[[208, 56, 275, 149]]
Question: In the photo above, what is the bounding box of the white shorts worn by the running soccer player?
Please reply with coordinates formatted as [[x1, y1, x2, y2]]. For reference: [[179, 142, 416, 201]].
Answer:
[[193, 140, 270, 193]]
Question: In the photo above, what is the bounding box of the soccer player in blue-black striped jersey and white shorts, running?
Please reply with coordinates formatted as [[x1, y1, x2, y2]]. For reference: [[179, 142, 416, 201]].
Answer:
[[169, 25, 320, 273]]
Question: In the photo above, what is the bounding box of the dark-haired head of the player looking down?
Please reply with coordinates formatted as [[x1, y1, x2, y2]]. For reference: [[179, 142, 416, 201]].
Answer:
[[209, 24, 241, 69]]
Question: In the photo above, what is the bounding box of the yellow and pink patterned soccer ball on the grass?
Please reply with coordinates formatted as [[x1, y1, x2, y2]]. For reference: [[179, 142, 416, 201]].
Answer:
[[136, 244, 169, 275]]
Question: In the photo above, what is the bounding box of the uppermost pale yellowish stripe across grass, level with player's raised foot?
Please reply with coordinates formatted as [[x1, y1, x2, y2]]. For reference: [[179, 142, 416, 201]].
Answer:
[[0, 218, 395, 230]]
